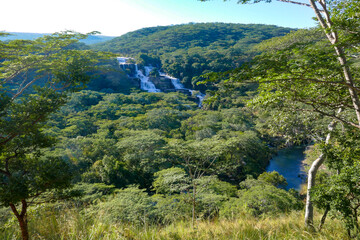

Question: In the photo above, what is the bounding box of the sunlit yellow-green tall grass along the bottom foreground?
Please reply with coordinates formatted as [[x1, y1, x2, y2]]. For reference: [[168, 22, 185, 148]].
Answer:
[[0, 208, 347, 240]]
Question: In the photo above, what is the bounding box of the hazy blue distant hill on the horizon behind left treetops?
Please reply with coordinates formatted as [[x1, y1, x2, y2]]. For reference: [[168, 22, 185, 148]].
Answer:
[[0, 32, 114, 45]]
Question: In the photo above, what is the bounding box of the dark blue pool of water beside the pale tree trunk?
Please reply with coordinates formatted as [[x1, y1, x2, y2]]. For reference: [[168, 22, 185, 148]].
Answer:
[[266, 147, 306, 190]]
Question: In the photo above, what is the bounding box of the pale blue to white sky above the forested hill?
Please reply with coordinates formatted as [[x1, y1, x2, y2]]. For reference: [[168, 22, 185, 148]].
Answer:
[[0, 0, 315, 36]]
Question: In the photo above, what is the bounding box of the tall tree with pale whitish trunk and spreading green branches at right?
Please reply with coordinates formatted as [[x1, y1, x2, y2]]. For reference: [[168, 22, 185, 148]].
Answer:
[[203, 0, 360, 228]]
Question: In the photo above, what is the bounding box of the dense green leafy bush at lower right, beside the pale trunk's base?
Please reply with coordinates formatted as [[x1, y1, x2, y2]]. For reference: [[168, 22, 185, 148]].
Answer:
[[311, 129, 360, 237]]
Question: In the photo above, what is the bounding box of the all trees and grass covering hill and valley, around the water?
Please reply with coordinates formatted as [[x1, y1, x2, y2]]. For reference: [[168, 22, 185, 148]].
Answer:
[[0, 1, 360, 240]]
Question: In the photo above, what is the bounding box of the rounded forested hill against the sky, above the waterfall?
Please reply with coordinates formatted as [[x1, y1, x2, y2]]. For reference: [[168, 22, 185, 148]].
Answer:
[[92, 23, 292, 91]]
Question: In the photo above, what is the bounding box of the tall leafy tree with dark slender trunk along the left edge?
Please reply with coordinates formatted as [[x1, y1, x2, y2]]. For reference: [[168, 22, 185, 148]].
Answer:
[[0, 32, 110, 239]]
